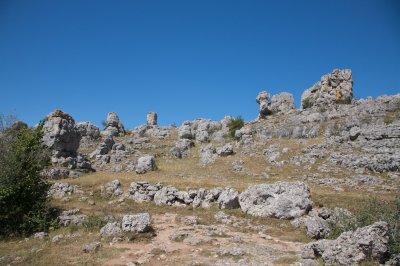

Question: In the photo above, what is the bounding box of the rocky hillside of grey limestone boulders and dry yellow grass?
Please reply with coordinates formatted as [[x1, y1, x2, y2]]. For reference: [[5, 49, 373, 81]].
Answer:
[[0, 69, 400, 265]]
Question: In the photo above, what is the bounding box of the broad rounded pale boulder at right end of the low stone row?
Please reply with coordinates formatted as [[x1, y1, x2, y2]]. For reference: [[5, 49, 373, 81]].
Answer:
[[239, 182, 312, 219]]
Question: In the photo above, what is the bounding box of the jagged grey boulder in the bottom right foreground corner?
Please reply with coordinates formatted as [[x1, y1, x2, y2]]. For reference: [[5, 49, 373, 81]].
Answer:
[[302, 222, 389, 265]]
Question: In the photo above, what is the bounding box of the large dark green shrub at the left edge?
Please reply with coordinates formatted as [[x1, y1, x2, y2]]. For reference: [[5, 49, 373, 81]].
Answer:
[[0, 117, 56, 237]]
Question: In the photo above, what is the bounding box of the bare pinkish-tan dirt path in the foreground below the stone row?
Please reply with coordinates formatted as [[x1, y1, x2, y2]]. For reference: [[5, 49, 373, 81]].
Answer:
[[105, 213, 302, 266]]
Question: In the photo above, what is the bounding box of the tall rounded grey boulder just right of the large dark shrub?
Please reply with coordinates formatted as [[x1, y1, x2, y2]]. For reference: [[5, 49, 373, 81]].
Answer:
[[43, 110, 81, 155]]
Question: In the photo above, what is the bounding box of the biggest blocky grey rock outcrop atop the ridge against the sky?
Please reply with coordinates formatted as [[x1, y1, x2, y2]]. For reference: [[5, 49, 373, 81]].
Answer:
[[301, 69, 353, 109]]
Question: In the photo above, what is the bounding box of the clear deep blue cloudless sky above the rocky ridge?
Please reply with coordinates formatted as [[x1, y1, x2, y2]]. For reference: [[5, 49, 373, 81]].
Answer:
[[0, 0, 400, 128]]
